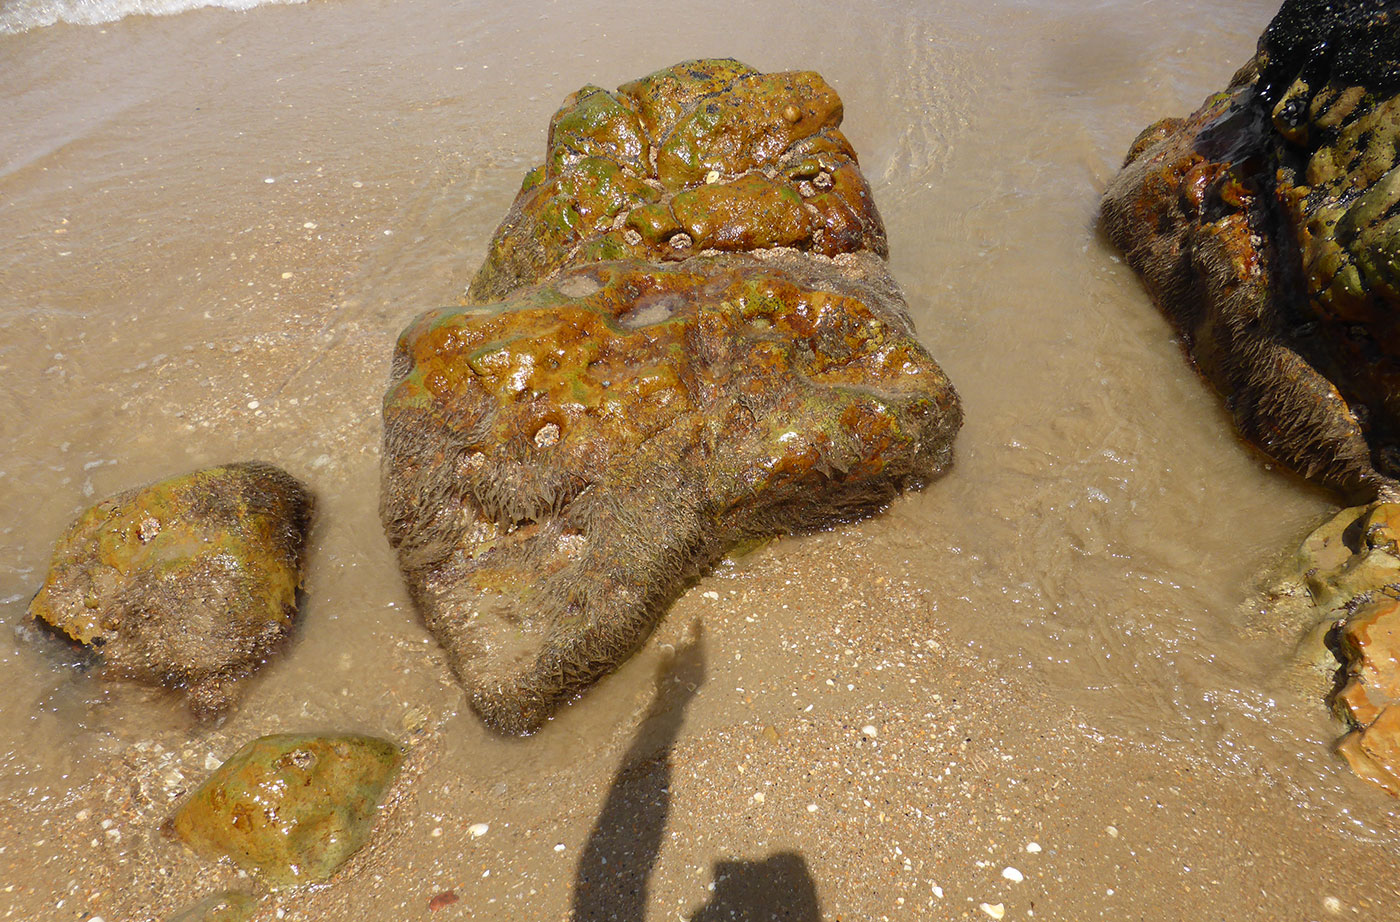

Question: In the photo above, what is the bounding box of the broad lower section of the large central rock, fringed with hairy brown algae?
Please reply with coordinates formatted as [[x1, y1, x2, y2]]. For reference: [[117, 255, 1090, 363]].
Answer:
[[382, 250, 960, 733]]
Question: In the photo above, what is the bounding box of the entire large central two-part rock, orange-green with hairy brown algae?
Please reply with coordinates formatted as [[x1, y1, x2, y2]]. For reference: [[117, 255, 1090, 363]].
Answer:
[[381, 62, 962, 733]]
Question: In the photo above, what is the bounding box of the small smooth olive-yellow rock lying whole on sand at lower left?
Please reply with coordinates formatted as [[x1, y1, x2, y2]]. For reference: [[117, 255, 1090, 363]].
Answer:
[[169, 733, 403, 888]]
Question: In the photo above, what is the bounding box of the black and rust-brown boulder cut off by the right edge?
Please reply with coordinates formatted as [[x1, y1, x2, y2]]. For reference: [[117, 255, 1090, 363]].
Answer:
[[1103, 0, 1400, 501]]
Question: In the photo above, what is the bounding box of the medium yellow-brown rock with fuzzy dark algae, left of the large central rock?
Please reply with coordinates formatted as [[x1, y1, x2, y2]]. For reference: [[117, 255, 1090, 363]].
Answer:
[[29, 462, 312, 715]]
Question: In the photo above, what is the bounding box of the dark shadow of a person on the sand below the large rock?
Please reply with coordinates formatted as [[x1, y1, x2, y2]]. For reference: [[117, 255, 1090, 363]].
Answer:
[[573, 625, 822, 922]]
